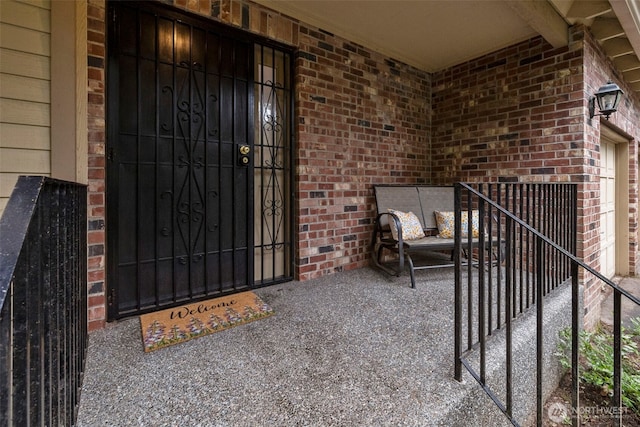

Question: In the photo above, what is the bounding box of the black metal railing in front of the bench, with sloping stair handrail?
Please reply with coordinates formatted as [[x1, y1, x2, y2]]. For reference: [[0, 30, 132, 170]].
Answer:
[[454, 183, 640, 426]]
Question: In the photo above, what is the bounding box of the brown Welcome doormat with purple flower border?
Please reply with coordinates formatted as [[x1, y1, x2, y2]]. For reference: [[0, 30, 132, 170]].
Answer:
[[140, 292, 274, 352]]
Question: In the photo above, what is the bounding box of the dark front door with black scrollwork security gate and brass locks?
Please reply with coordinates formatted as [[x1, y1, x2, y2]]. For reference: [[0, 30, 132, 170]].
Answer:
[[105, 2, 254, 319]]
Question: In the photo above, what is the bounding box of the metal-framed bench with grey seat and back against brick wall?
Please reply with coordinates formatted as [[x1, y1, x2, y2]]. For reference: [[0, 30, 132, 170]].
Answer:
[[370, 185, 498, 288]]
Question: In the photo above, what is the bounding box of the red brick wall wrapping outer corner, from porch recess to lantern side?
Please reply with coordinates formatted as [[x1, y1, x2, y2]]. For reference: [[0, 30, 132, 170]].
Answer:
[[430, 27, 640, 326]]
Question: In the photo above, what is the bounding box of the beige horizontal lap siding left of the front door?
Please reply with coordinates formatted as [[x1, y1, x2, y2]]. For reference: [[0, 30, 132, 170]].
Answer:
[[0, 0, 51, 214]]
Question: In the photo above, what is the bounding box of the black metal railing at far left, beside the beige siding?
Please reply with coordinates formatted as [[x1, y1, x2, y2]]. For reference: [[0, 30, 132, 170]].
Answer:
[[0, 176, 87, 426]]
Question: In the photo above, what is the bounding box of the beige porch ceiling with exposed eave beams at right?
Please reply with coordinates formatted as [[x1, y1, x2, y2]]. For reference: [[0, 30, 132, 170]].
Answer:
[[255, 0, 640, 94]]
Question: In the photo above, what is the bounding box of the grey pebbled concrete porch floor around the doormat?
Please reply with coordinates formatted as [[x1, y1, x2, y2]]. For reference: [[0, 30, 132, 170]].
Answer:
[[78, 268, 506, 426]]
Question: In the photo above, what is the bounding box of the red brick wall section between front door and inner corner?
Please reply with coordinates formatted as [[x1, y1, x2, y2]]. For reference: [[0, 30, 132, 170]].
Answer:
[[296, 25, 430, 280]]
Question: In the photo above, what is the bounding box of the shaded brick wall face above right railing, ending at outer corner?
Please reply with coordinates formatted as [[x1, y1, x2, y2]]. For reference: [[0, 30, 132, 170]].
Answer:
[[431, 37, 589, 183]]
